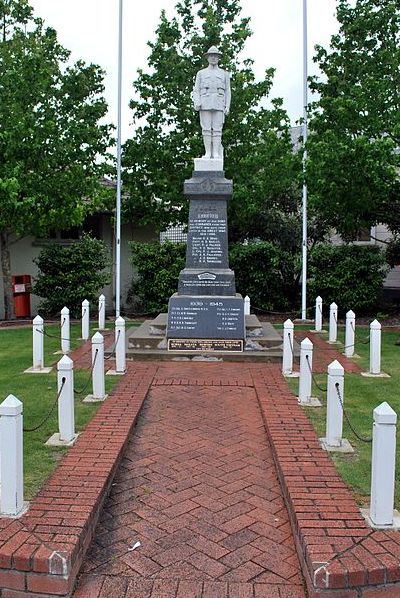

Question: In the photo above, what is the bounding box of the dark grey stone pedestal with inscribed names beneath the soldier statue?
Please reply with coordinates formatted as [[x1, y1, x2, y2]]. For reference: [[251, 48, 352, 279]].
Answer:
[[167, 169, 245, 351]]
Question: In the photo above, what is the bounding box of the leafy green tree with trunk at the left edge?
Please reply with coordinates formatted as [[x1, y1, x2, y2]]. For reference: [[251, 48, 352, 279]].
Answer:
[[0, 0, 110, 318]]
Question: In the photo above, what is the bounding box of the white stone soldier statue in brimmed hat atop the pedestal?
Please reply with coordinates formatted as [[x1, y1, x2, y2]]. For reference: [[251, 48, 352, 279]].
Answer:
[[192, 46, 231, 159]]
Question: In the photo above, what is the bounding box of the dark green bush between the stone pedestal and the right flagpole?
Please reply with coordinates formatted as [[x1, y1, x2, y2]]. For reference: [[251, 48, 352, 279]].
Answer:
[[229, 241, 298, 311]]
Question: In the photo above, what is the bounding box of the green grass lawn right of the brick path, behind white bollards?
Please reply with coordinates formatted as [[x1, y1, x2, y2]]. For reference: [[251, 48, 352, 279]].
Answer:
[[282, 326, 400, 508]]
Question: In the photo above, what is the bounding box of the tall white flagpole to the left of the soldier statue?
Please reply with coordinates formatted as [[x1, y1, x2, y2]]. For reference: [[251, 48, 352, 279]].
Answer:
[[115, 0, 123, 318]]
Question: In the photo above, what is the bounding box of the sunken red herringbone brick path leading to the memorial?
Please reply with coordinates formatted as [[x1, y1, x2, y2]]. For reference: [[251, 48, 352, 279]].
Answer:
[[75, 362, 306, 598]]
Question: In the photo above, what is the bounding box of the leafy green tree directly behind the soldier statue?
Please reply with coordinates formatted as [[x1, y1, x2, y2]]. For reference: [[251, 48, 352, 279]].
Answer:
[[123, 0, 301, 247]]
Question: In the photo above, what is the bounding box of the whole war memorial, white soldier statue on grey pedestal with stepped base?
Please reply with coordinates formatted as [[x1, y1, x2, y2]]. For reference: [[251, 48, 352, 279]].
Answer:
[[128, 46, 282, 359]]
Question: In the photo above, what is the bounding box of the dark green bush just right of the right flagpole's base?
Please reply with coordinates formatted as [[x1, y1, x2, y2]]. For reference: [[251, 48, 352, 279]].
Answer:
[[307, 244, 387, 313]]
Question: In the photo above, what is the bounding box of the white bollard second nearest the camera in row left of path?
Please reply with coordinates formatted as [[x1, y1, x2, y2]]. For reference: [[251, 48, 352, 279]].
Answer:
[[57, 355, 75, 443]]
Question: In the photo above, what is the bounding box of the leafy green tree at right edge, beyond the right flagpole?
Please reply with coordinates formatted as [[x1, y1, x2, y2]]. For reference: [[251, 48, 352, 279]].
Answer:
[[308, 0, 400, 239]]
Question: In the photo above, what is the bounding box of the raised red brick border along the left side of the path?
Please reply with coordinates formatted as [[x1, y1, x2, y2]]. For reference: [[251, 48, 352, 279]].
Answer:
[[0, 362, 158, 598]]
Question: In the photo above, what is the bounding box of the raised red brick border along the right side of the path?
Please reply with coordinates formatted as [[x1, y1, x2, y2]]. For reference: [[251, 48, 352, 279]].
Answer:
[[252, 366, 400, 598]]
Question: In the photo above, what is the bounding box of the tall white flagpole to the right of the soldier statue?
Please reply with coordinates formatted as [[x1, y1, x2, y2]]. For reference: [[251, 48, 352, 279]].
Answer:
[[301, 0, 308, 320]]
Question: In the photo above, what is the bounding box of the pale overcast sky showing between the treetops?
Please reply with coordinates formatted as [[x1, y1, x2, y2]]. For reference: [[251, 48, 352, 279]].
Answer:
[[30, 0, 338, 141]]
